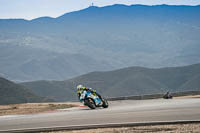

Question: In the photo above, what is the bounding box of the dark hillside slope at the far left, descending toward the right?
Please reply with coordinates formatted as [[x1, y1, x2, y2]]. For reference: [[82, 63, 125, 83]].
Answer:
[[0, 77, 53, 105]]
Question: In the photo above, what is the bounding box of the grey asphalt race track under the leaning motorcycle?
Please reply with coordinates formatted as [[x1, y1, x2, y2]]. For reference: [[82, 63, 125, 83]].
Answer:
[[0, 98, 200, 132]]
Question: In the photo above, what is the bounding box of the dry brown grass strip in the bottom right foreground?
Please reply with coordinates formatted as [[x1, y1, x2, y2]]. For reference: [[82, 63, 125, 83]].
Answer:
[[43, 124, 200, 133]]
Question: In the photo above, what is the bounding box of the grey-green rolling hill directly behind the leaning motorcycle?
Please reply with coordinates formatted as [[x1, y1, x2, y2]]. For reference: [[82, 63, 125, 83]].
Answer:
[[22, 64, 200, 101]]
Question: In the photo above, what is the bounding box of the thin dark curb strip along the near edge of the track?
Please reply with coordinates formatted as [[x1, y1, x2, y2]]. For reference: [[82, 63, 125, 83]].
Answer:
[[0, 120, 200, 133]]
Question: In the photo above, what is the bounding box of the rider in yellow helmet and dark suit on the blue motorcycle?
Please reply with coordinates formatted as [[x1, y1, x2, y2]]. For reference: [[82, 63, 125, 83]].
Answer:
[[77, 85, 102, 100]]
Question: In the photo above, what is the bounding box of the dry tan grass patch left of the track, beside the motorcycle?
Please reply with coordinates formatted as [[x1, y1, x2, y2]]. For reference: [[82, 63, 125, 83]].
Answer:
[[0, 103, 77, 116]]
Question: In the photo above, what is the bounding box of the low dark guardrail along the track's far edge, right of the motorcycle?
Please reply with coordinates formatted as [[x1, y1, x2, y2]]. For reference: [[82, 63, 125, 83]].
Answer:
[[107, 91, 200, 101]]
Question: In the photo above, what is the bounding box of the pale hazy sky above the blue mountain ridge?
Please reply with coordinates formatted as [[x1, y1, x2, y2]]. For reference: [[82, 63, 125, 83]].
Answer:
[[0, 0, 200, 19]]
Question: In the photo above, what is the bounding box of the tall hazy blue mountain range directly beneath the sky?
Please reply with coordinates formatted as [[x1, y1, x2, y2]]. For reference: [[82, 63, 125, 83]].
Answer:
[[0, 5, 200, 81]]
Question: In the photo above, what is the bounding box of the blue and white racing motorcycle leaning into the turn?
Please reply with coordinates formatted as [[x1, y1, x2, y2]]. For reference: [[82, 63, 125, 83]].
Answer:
[[80, 91, 108, 109]]
